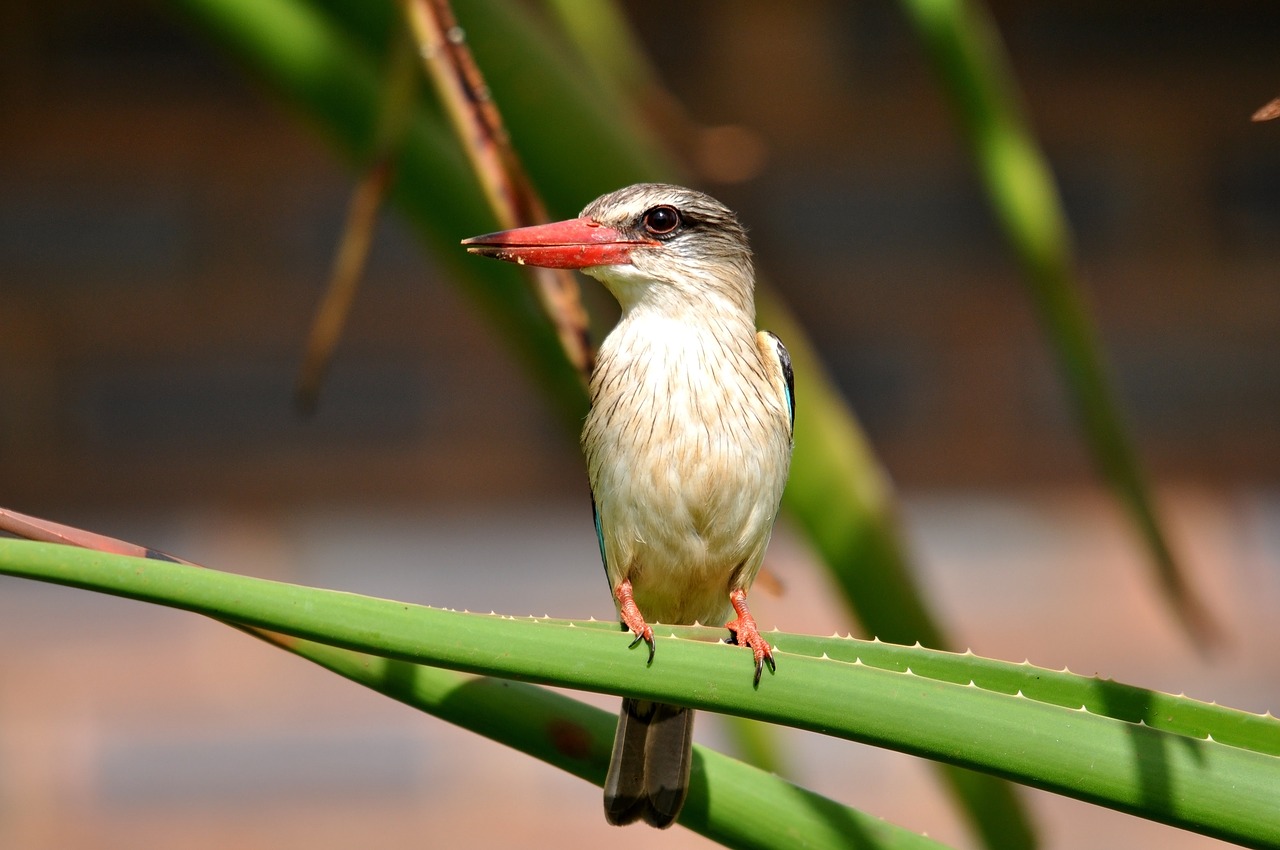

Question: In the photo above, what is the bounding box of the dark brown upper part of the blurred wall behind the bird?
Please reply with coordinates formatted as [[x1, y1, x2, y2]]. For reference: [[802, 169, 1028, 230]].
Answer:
[[0, 3, 1280, 508]]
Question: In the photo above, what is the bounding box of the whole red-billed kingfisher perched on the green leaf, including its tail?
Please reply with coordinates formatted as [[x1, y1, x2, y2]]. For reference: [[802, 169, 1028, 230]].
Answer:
[[462, 183, 795, 828]]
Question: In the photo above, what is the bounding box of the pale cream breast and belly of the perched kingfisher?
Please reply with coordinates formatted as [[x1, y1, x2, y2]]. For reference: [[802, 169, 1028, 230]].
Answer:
[[585, 327, 790, 625]]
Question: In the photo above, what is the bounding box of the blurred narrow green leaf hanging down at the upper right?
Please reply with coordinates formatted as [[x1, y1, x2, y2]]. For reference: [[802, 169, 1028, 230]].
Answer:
[[902, 0, 1217, 643]]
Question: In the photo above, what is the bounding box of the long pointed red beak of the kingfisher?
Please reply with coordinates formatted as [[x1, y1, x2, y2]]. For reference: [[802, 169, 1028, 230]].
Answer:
[[462, 219, 658, 269]]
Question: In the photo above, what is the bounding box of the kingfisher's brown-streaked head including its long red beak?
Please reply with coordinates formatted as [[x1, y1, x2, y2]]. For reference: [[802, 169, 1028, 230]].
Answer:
[[462, 183, 754, 311]]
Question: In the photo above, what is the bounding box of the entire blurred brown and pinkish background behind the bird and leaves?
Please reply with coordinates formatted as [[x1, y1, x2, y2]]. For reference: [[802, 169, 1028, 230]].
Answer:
[[0, 0, 1280, 850]]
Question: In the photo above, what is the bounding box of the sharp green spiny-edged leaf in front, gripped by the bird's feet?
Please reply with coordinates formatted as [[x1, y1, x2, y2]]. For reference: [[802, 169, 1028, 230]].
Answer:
[[0, 540, 1280, 846]]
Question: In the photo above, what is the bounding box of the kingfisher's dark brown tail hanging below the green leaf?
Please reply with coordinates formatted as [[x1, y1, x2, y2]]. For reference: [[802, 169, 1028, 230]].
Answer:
[[604, 698, 694, 830]]
